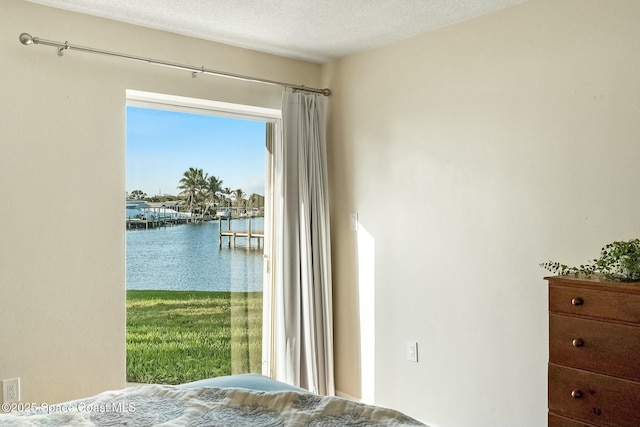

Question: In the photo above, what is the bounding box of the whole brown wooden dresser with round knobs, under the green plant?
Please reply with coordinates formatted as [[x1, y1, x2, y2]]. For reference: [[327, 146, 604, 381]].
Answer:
[[546, 276, 640, 427]]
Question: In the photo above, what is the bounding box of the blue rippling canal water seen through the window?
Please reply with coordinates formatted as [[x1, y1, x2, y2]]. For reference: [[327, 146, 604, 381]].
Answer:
[[126, 217, 264, 292]]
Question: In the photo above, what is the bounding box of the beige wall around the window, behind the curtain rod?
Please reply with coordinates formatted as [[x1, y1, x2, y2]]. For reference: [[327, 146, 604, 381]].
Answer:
[[0, 0, 320, 403]]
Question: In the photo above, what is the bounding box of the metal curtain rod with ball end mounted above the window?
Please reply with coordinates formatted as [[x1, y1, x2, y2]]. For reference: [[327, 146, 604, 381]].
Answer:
[[19, 33, 331, 96]]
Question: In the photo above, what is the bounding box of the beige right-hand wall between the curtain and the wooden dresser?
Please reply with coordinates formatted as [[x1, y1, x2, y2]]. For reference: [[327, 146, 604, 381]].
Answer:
[[323, 0, 640, 427]]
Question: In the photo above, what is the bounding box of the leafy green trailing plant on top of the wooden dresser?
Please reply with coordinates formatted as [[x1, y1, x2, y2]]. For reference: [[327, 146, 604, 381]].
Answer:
[[540, 239, 640, 282]]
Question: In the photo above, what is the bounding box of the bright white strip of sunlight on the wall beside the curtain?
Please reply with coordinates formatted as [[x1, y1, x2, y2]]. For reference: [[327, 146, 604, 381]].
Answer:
[[357, 223, 376, 404]]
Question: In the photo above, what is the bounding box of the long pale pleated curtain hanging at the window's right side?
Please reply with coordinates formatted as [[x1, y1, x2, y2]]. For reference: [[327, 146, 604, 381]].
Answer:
[[271, 89, 335, 395]]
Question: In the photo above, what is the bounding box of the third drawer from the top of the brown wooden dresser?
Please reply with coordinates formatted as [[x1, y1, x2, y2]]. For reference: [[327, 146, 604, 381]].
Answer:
[[549, 363, 640, 427]]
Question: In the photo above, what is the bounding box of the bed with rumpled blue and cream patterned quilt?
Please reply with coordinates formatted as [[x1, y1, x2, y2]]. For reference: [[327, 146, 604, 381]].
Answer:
[[0, 374, 424, 427]]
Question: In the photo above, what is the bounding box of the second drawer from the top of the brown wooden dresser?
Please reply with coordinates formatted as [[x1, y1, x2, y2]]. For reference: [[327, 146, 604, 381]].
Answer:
[[549, 314, 640, 381]]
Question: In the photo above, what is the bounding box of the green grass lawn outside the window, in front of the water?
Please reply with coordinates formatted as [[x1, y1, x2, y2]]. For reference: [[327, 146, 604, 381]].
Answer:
[[127, 291, 262, 384]]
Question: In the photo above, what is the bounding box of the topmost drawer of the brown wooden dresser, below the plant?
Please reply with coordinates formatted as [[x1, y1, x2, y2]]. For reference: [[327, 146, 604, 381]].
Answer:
[[549, 284, 640, 325]]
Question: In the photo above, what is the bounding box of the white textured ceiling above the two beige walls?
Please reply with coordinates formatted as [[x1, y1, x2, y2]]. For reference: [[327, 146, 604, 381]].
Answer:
[[23, 0, 526, 63]]
